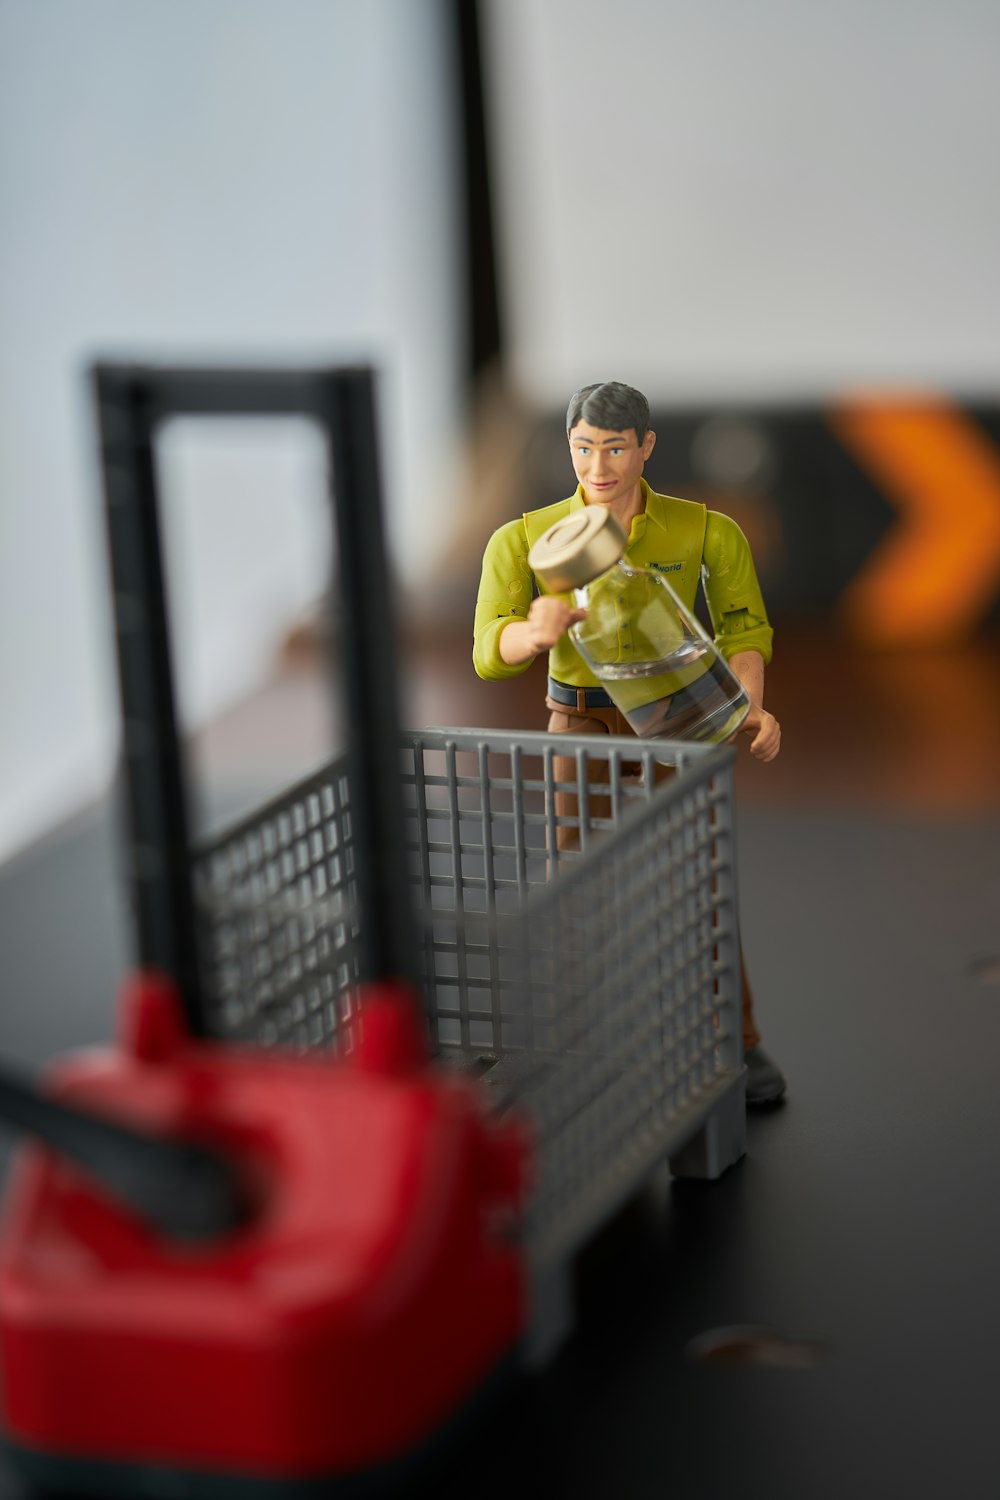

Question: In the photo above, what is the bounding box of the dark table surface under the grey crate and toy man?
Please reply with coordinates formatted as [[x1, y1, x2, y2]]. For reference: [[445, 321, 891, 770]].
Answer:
[[0, 636, 1000, 1500]]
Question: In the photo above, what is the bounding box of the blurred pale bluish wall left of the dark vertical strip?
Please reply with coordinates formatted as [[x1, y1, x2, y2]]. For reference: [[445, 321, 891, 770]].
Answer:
[[0, 0, 459, 854]]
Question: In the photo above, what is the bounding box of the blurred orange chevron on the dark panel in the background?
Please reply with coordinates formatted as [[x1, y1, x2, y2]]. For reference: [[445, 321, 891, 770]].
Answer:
[[831, 396, 1000, 647]]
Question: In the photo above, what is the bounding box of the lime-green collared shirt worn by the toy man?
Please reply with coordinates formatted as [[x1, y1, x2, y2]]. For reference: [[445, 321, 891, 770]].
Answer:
[[472, 480, 772, 687]]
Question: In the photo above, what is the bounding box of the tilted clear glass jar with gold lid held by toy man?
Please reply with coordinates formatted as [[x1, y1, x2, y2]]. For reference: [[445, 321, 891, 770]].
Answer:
[[528, 506, 750, 744]]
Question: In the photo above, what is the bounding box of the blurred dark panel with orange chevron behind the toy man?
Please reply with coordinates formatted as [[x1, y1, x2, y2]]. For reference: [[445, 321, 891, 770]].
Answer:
[[515, 396, 1000, 647]]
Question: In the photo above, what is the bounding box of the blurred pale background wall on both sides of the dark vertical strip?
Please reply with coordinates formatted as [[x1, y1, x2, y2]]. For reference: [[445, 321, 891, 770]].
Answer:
[[0, 0, 1000, 854]]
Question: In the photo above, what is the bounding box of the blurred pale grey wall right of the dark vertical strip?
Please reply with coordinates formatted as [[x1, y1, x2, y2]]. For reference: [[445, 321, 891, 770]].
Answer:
[[487, 0, 1000, 408]]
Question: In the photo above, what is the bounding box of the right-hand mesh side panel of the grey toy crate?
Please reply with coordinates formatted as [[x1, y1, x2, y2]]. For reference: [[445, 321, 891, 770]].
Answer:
[[487, 771, 741, 1263]]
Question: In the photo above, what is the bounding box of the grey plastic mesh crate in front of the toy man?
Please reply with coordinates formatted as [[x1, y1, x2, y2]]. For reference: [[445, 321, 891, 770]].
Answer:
[[195, 729, 744, 1262]]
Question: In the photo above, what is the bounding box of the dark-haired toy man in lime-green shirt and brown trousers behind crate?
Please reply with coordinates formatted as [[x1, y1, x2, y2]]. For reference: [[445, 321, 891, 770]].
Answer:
[[472, 381, 786, 1106]]
